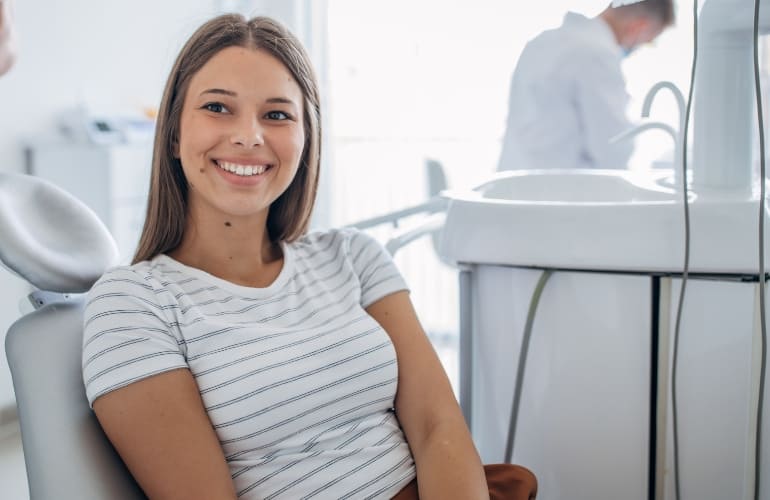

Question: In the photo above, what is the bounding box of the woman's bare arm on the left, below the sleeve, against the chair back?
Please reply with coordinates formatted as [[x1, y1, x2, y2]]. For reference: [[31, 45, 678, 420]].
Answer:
[[93, 369, 236, 500]]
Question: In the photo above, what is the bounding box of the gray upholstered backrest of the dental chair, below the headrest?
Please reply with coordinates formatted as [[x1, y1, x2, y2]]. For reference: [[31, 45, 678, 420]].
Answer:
[[5, 296, 145, 500]]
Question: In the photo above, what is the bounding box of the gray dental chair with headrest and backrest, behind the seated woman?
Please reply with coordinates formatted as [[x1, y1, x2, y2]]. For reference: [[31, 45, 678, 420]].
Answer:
[[0, 173, 146, 500]]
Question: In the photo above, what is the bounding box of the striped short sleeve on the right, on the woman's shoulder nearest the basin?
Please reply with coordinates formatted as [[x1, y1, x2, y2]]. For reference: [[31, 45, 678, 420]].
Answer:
[[348, 230, 409, 308]]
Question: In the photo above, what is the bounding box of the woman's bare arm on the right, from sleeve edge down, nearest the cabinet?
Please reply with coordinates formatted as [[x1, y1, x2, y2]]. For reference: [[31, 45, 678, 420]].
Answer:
[[366, 291, 489, 500]]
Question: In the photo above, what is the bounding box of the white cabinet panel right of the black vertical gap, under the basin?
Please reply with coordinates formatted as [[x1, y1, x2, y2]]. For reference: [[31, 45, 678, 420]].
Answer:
[[666, 279, 770, 500]]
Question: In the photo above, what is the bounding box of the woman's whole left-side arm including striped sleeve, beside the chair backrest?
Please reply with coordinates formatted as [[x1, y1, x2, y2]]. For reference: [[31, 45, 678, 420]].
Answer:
[[83, 268, 235, 499]]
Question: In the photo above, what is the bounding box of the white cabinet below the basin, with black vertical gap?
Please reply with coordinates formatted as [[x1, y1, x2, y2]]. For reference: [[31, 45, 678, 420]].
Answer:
[[461, 265, 770, 500]]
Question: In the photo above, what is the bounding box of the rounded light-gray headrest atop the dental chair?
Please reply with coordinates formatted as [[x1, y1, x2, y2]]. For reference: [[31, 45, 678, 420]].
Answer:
[[0, 172, 119, 293]]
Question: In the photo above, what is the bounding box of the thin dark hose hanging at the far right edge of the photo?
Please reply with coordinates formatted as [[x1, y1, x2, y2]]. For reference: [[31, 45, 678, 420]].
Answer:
[[754, 0, 767, 500]]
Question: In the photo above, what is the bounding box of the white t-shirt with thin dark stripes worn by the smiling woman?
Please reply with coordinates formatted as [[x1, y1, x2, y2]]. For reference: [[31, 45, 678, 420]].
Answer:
[[83, 230, 415, 499]]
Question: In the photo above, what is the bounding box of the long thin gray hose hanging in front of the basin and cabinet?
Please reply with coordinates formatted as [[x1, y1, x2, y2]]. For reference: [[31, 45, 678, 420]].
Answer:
[[671, 0, 698, 500]]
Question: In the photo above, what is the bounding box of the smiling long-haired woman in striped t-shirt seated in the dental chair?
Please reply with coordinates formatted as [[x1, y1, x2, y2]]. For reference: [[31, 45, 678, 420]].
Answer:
[[78, 11, 536, 500]]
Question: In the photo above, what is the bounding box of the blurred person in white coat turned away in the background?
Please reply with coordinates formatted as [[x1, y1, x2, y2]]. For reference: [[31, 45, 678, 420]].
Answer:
[[498, 0, 674, 170]]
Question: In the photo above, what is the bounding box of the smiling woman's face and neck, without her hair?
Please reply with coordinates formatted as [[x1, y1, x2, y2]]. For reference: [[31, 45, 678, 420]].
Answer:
[[169, 47, 305, 286]]
